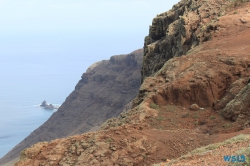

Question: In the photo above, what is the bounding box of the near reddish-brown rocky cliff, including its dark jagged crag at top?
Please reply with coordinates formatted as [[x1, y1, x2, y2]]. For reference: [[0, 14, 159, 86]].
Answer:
[[12, 0, 250, 166]]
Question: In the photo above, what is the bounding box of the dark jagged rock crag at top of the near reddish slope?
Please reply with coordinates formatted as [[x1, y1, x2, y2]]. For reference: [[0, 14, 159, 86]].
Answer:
[[142, 0, 230, 81]]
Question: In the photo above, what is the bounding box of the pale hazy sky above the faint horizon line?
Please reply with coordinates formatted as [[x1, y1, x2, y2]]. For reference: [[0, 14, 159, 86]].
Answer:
[[0, 0, 178, 34]]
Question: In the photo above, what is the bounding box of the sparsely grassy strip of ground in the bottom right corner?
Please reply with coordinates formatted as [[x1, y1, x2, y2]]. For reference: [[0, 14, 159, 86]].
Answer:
[[158, 131, 250, 166]]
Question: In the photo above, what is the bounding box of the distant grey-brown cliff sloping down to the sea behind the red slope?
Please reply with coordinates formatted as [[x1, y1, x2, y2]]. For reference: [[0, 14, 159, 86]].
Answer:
[[0, 49, 143, 164]]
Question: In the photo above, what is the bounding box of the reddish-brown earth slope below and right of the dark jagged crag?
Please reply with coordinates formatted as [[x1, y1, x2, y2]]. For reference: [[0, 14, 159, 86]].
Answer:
[[15, 0, 250, 166]]
